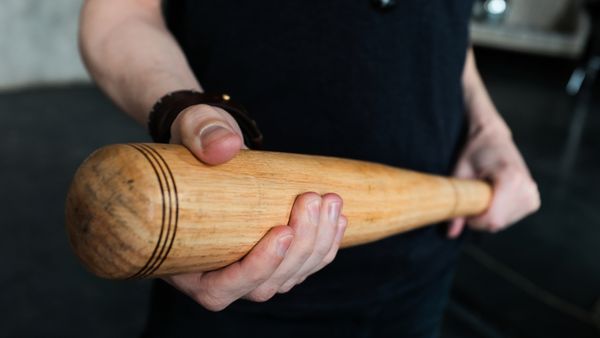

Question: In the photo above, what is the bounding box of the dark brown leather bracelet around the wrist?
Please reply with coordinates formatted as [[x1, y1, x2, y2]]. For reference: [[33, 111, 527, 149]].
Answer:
[[148, 90, 263, 149]]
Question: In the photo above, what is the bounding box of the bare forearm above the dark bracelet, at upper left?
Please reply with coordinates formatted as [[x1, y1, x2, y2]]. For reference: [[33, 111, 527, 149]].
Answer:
[[80, 0, 201, 124]]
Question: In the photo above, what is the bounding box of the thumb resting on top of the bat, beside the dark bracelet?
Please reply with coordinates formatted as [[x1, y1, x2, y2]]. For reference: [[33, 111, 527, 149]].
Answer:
[[171, 105, 243, 165]]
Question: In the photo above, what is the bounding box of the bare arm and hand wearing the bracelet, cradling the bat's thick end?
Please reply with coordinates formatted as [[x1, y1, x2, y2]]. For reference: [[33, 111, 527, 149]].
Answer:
[[80, 0, 347, 311]]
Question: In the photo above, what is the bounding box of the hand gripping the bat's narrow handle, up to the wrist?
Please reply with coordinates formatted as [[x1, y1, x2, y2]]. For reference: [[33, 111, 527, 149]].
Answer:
[[448, 115, 540, 238]]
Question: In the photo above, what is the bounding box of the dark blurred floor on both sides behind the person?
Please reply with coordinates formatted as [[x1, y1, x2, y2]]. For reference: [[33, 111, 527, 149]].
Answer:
[[0, 51, 600, 338]]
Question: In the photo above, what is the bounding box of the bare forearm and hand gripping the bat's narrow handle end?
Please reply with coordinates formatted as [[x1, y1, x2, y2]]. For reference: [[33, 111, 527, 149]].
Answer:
[[448, 48, 540, 238]]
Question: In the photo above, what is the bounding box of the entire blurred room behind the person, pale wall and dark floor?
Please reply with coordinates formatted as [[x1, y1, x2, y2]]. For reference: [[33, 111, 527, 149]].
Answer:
[[0, 0, 600, 337]]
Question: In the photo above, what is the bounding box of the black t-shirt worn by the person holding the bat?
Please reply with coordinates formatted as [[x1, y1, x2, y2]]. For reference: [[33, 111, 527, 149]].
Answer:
[[166, 0, 472, 311]]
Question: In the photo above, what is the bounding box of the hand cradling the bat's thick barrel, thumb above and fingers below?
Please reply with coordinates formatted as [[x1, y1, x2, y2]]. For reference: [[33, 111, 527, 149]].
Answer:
[[165, 105, 347, 311]]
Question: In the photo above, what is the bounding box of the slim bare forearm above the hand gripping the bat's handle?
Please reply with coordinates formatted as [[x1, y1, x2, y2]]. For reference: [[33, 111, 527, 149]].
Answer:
[[462, 48, 510, 135]]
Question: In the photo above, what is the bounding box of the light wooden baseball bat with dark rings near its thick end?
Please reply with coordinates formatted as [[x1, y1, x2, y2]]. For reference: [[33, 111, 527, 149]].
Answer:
[[66, 144, 492, 279]]
